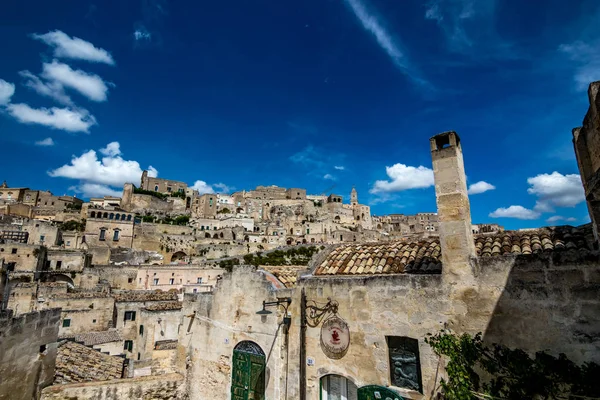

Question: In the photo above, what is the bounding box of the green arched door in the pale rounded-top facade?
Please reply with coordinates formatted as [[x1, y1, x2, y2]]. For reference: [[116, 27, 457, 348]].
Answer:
[[231, 340, 266, 400]]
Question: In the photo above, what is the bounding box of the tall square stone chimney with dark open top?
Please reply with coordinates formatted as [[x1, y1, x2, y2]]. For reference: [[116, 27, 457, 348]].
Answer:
[[430, 131, 477, 281]]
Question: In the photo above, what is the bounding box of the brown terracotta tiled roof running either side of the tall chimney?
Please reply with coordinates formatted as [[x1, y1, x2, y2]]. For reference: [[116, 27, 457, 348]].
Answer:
[[314, 225, 591, 275]]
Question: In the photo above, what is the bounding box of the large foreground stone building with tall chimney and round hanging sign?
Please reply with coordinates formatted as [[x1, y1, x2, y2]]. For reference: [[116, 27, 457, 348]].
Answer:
[[179, 132, 600, 400]]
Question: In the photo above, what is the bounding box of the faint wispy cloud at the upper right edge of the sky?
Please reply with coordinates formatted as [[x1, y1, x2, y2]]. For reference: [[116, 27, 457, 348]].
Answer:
[[558, 40, 600, 91]]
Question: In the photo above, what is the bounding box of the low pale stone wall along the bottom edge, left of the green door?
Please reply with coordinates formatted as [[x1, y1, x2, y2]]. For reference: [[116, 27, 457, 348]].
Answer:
[[41, 374, 185, 400]]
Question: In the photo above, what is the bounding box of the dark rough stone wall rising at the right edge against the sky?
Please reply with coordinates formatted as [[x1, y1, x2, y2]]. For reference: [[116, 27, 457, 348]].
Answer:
[[573, 81, 600, 246]]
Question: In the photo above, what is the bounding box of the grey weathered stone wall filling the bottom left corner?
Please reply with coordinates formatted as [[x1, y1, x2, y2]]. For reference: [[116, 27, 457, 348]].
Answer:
[[0, 309, 60, 400]]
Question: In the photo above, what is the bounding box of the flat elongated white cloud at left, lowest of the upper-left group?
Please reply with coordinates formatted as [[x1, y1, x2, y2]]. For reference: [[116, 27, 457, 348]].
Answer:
[[6, 103, 96, 132]]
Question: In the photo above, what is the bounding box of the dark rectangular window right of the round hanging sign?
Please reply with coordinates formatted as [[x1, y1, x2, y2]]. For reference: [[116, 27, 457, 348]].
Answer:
[[386, 336, 423, 393]]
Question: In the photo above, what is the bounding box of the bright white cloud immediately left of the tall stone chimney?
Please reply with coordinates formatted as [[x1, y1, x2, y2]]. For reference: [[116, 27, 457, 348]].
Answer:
[[369, 164, 434, 194]]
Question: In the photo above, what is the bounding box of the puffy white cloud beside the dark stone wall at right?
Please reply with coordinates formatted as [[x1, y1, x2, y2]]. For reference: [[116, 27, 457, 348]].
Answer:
[[527, 171, 585, 212]]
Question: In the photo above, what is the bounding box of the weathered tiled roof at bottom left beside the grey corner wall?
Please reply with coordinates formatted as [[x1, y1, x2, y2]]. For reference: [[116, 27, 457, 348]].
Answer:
[[54, 341, 124, 384]]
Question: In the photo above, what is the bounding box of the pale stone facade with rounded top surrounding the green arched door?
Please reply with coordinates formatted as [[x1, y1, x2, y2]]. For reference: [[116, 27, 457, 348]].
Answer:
[[179, 267, 288, 399]]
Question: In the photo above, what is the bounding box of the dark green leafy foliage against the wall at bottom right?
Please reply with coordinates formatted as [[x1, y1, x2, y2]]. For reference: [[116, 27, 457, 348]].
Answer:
[[425, 329, 600, 400]]
